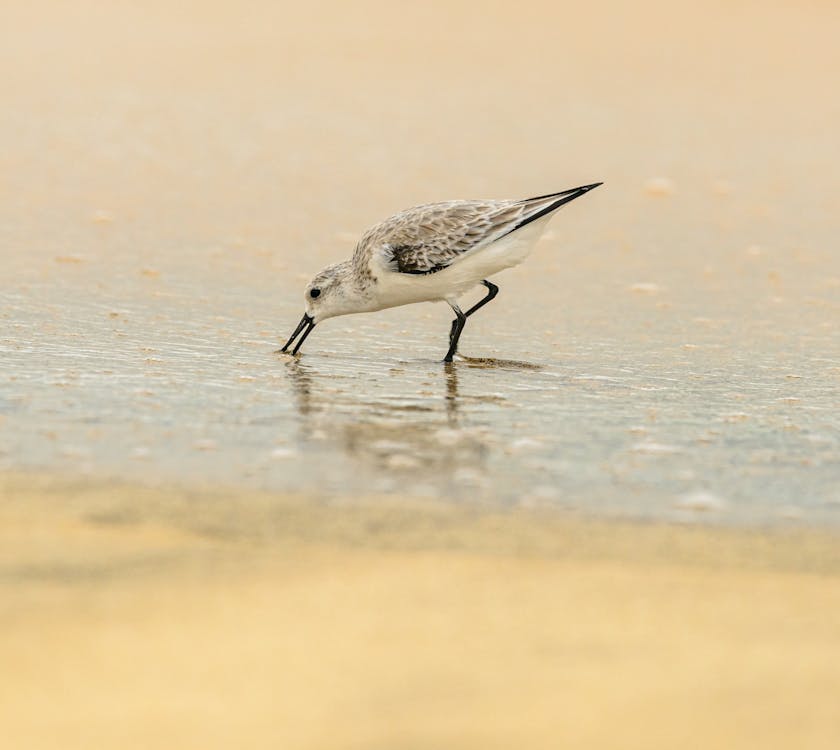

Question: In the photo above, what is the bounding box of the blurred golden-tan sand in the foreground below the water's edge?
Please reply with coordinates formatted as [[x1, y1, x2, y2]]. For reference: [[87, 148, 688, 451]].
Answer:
[[0, 476, 840, 750]]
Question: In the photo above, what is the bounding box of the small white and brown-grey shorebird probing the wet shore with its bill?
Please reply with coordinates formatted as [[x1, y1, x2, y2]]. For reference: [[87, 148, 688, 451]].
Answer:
[[280, 187, 603, 362]]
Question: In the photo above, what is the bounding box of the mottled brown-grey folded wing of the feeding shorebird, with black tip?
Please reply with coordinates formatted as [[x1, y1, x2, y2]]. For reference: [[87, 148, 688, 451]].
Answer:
[[354, 185, 595, 276]]
